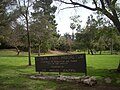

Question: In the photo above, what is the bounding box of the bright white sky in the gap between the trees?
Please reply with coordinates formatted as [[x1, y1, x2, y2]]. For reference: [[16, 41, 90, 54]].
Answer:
[[55, 1, 93, 35]]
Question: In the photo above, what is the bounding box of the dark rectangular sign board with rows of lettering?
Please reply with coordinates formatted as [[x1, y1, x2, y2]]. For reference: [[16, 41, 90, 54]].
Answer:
[[35, 54, 86, 73]]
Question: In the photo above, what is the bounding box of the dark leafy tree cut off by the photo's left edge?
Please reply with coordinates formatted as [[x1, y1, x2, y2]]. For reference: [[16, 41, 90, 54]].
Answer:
[[0, 0, 24, 50]]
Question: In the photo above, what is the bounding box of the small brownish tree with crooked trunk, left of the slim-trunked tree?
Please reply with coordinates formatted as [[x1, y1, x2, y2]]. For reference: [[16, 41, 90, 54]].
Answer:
[[5, 22, 24, 55]]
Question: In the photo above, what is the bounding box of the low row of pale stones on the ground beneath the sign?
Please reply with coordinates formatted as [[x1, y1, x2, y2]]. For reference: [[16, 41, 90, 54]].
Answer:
[[30, 75, 97, 86]]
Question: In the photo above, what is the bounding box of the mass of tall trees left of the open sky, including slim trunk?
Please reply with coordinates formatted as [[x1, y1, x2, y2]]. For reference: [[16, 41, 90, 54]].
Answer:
[[0, 0, 59, 65]]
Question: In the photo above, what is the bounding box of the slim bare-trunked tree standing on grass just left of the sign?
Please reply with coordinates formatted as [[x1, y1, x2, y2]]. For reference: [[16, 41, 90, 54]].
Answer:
[[14, 0, 33, 66]]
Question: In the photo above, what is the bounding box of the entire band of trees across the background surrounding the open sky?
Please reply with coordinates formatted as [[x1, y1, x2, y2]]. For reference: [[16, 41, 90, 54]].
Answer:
[[0, 0, 120, 61]]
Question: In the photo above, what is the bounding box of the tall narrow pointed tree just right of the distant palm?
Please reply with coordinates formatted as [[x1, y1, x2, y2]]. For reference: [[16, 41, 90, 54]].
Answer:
[[82, 15, 97, 55]]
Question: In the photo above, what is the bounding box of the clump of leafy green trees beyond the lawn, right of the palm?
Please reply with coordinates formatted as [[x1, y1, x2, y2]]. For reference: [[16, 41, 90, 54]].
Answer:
[[75, 14, 118, 54]]
